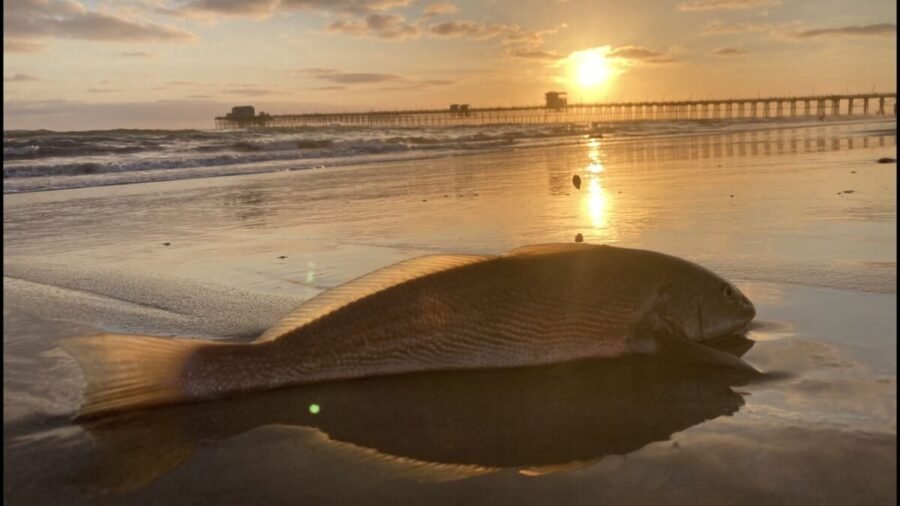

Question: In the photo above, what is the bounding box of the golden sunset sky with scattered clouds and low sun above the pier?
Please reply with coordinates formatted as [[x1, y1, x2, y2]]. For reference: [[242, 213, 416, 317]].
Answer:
[[3, 0, 897, 130]]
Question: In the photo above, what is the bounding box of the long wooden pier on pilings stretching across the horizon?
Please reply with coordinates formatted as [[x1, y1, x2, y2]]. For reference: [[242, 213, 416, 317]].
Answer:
[[216, 93, 897, 129]]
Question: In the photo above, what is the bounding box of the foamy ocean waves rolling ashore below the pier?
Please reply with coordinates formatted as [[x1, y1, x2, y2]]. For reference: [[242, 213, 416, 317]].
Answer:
[[3, 117, 892, 192]]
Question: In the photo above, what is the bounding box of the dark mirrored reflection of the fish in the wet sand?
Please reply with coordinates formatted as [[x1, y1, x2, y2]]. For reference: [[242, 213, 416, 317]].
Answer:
[[82, 342, 752, 492]]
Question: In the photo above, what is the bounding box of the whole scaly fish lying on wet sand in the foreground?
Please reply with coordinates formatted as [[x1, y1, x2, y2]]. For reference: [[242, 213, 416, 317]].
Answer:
[[61, 243, 756, 418]]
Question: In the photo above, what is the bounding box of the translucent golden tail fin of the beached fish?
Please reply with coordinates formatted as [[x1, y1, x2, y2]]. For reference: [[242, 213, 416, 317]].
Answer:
[[60, 334, 220, 418]]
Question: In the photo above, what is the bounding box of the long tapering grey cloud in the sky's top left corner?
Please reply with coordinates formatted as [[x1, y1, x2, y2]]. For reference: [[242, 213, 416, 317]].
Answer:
[[3, 0, 196, 42]]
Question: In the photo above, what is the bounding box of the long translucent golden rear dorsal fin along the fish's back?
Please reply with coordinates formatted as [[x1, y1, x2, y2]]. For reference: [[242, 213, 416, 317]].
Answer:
[[257, 255, 494, 341]]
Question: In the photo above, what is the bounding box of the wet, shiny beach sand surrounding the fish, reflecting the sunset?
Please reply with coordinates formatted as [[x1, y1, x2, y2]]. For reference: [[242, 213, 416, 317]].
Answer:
[[4, 121, 897, 504]]
